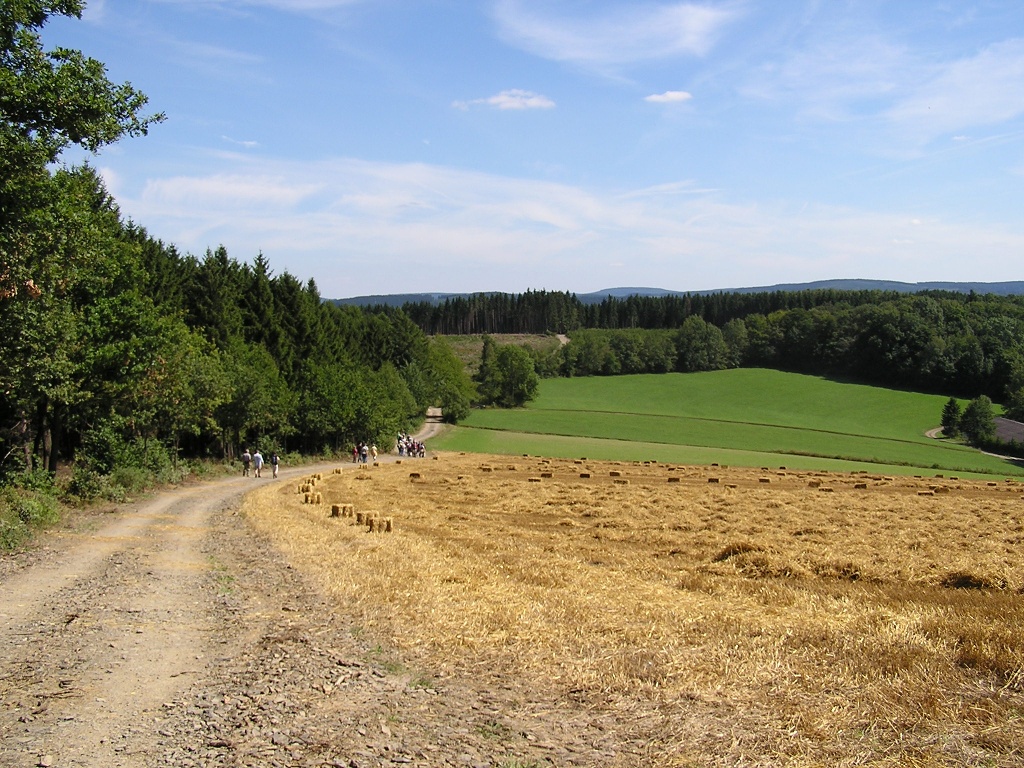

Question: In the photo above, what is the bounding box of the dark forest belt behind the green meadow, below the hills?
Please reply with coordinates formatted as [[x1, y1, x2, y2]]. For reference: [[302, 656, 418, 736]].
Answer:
[[402, 289, 1024, 416]]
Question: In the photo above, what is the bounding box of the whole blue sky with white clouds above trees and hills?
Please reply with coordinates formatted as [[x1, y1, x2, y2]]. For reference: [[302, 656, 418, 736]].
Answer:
[[43, 0, 1024, 298]]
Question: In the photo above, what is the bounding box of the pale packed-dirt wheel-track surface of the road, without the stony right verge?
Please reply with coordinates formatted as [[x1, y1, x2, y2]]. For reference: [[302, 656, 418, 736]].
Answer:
[[0, 478, 305, 766]]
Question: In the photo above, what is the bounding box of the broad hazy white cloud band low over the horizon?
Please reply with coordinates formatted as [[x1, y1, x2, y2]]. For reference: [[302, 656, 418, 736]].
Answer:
[[112, 158, 1024, 297]]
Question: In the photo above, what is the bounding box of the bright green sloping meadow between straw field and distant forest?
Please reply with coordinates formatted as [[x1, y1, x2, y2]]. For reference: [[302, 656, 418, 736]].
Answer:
[[431, 369, 1024, 477]]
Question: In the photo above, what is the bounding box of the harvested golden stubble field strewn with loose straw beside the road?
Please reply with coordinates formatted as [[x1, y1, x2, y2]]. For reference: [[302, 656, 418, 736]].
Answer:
[[241, 455, 1024, 766]]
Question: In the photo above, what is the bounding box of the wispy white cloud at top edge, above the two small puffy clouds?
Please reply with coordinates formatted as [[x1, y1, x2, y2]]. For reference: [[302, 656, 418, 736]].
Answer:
[[494, 0, 739, 68]]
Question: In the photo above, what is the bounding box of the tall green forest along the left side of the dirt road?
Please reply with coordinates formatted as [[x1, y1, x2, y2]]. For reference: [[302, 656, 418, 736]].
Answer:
[[0, 0, 472, 520]]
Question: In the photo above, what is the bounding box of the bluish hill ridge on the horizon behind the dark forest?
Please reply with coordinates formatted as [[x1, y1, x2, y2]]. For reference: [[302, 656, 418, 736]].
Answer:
[[333, 280, 1024, 306]]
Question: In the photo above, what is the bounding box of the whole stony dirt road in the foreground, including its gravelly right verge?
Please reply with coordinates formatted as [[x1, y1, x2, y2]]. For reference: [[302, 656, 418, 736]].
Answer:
[[0, 450, 614, 768]]
